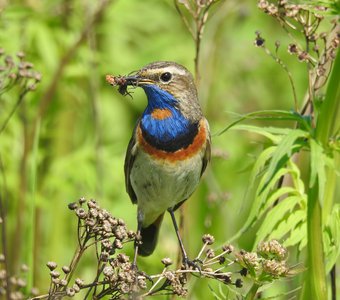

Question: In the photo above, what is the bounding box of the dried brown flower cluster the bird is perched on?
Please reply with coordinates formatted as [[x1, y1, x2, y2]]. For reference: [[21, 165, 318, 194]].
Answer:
[[19, 198, 298, 299]]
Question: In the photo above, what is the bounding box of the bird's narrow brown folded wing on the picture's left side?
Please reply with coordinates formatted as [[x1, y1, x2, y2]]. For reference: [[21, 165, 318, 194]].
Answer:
[[124, 122, 139, 203]]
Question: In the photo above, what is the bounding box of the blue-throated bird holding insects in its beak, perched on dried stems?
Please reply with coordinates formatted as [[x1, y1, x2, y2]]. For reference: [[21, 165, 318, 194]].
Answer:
[[107, 61, 210, 265]]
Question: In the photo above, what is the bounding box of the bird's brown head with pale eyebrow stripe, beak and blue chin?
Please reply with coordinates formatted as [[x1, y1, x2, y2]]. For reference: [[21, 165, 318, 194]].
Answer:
[[124, 61, 202, 120]]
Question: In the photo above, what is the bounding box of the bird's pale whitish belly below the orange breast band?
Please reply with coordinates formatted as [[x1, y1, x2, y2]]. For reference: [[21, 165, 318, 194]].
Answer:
[[130, 151, 202, 227]]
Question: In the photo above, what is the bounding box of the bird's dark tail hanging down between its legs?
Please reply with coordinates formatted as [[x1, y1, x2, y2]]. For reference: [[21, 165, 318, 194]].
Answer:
[[138, 213, 164, 256]]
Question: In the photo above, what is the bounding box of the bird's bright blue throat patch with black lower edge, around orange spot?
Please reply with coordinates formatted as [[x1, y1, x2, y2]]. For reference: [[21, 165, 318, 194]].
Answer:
[[141, 85, 198, 152]]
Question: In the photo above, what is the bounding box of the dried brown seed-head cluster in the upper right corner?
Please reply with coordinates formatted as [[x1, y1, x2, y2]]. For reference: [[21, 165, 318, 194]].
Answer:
[[255, 0, 340, 113]]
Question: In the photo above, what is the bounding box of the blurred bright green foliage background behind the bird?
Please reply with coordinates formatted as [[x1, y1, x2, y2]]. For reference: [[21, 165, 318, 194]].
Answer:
[[0, 0, 330, 299]]
